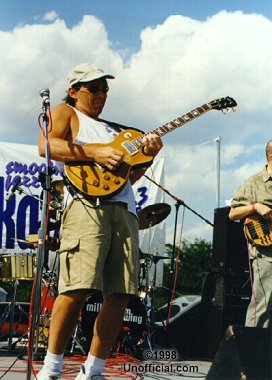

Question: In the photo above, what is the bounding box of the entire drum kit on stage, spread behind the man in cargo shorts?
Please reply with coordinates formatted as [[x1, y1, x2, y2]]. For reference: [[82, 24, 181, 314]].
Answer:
[[0, 189, 171, 357]]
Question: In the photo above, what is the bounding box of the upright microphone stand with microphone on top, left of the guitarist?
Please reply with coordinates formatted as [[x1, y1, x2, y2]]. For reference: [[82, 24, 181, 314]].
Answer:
[[27, 89, 52, 380]]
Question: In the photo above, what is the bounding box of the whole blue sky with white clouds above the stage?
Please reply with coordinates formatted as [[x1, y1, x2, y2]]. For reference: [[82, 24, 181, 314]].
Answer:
[[0, 0, 272, 242]]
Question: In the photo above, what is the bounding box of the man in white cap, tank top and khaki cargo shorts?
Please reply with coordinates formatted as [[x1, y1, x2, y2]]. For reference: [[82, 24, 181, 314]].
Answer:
[[38, 63, 162, 380]]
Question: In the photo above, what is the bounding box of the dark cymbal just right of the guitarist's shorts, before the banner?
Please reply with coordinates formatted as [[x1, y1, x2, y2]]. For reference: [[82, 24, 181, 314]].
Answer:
[[138, 203, 171, 230]]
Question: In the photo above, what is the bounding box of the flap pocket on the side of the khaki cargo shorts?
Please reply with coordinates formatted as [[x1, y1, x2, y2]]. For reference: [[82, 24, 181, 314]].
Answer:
[[58, 239, 81, 285]]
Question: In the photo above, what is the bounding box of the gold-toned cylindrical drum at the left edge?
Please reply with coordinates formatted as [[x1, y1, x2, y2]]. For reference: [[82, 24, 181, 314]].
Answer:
[[0, 252, 37, 280]]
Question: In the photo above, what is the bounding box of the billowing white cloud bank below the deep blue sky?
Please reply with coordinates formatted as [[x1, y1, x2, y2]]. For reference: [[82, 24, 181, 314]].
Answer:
[[0, 11, 272, 242]]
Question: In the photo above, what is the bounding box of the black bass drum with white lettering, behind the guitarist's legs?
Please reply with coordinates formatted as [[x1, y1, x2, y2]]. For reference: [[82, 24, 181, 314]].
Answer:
[[81, 292, 147, 353]]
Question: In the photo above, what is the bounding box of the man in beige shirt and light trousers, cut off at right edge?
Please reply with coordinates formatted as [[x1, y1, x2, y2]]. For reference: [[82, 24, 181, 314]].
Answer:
[[229, 140, 272, 327]]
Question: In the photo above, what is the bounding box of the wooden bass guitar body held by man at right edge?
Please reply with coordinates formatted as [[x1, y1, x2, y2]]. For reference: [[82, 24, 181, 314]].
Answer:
[[244, 214, 272, 247]]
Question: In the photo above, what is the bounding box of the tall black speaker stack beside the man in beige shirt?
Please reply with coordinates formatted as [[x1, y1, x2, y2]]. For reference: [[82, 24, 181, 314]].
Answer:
[[205, 207, 251, 358]]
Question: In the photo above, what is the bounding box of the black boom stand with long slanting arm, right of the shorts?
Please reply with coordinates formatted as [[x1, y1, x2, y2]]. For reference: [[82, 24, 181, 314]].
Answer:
[[144, 174, 214, 327]]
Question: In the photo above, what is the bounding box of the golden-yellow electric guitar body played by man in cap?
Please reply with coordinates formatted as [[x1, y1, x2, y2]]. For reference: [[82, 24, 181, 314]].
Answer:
[[64, 129, 153, 198]]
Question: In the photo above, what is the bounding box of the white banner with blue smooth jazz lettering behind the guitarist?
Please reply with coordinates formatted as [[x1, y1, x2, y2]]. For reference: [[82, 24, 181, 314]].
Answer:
[[0, 142, 165, 284]]
